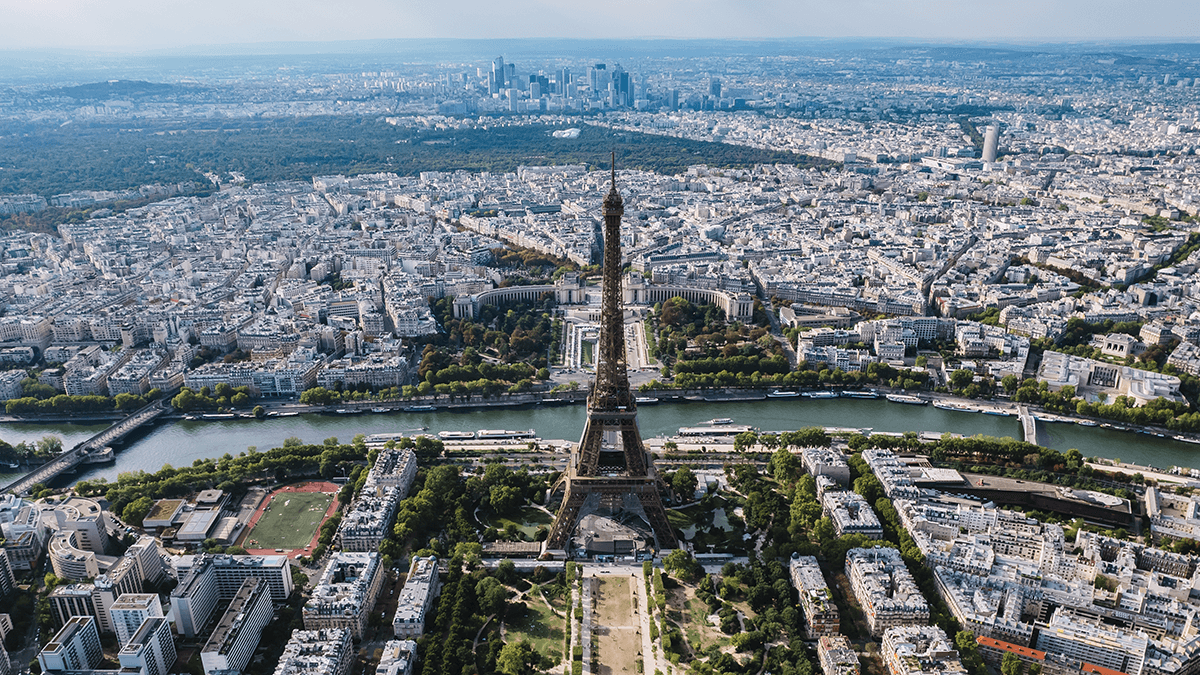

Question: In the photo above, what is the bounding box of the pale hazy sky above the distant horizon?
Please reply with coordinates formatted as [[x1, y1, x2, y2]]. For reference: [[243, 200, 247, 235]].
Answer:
[[0, 0, 1200, 50]]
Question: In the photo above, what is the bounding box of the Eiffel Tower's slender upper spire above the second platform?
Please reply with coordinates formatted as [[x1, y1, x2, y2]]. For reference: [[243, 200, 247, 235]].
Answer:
[[588, 153, 635, 413]]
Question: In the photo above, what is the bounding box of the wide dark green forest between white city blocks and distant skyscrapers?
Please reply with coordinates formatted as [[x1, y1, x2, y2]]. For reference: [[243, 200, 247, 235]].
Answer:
[[0, 117, 829, 196]]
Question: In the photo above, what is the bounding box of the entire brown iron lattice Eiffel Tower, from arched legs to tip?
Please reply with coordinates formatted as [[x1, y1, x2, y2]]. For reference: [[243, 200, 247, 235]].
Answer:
[[546, 153, 677, 549]]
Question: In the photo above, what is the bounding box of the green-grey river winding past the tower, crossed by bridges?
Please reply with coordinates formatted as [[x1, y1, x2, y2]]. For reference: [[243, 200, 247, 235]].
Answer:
[[0, 398, 1185, 480]]
